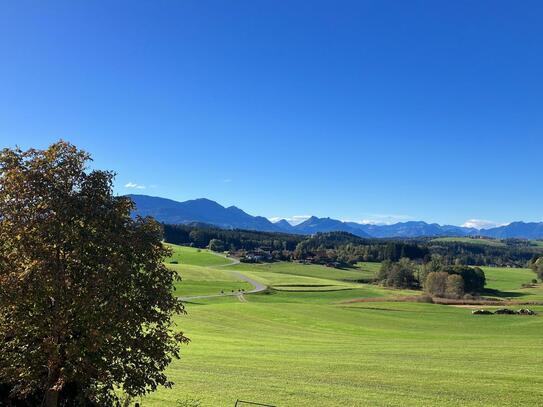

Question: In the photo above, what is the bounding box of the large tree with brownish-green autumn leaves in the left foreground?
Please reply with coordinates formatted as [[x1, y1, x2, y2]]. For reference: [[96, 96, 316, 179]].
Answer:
[[0, 141, 187, 406]]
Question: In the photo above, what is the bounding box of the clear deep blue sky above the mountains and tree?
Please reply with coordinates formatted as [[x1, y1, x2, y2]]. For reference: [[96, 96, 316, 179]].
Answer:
[[0, 0, 543, 224]]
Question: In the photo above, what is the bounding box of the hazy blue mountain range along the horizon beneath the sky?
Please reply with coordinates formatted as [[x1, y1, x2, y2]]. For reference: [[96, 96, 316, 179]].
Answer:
[[128, 195, 543, 239]]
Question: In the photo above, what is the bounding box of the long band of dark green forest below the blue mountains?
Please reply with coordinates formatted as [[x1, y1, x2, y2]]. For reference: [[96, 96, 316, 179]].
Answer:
[[164, 224, 543, 267]]
